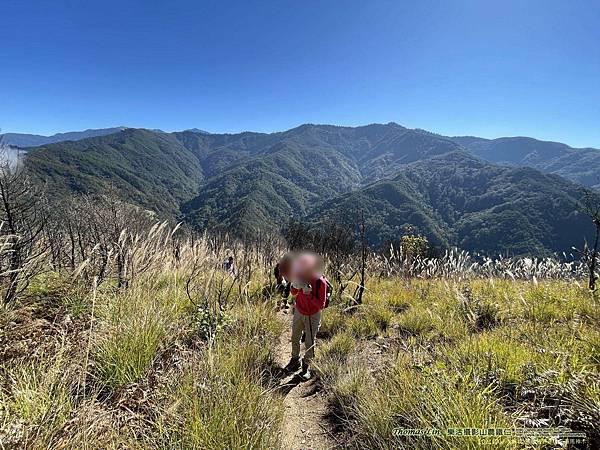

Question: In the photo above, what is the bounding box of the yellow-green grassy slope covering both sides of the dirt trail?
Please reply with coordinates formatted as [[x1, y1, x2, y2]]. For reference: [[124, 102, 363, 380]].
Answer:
[[0, 269, 600, 449]]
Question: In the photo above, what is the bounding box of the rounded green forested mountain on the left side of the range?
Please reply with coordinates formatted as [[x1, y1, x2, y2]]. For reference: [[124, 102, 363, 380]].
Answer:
[[25, 128, 203, 213]]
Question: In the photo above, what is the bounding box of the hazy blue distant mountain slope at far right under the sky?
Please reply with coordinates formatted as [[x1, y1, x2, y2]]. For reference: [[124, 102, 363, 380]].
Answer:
[[449, 136, 600, 189]]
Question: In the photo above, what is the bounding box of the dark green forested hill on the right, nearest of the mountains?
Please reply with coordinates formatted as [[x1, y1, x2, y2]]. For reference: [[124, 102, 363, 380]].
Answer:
[[311, 152, 592, 254]]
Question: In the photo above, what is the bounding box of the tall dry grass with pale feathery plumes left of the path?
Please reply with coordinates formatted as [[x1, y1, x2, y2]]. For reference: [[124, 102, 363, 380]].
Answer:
[[0, 225, 282, 448]]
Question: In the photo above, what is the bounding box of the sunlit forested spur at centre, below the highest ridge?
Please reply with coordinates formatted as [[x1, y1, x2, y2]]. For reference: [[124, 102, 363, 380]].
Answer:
[[182, 141, 360, 232]]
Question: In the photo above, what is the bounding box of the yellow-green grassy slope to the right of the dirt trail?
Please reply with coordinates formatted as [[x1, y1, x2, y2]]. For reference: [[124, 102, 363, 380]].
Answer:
[[317, 279, 600, 449]]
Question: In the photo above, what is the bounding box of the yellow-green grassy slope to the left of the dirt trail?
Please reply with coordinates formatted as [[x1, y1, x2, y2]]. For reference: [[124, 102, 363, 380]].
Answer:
[[0, 263, 282, 449]]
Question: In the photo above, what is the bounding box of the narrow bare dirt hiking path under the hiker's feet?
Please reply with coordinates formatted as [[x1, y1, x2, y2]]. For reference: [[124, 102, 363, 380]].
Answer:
[[276, 311, 339, 450]]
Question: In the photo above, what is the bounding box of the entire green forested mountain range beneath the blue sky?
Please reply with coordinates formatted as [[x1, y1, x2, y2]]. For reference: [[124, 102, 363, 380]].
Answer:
[[18, 123, 600, 255]]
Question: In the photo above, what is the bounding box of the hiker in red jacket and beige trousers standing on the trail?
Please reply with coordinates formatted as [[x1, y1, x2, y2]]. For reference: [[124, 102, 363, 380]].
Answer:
[[285, 253, 330, 380]]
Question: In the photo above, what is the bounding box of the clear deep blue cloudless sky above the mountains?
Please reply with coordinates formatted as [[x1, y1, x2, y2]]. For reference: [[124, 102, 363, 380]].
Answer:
[[0, 0, 600, 147]]
